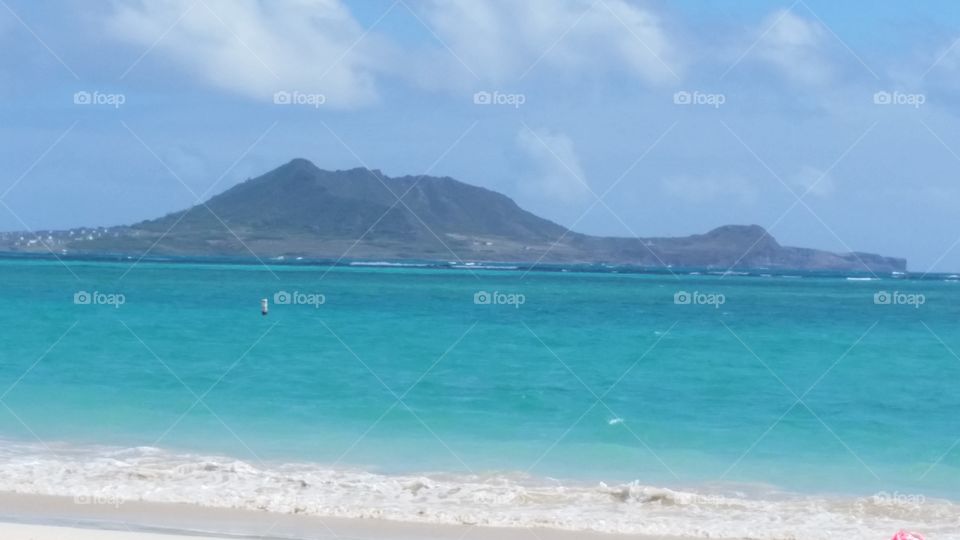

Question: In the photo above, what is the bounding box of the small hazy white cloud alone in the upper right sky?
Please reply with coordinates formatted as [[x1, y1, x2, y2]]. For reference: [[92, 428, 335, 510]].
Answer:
[[753, 10, 833, 84]]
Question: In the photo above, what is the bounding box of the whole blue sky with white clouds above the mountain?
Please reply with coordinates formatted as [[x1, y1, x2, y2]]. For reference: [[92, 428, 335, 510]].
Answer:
[[0, 0, 960, 272]]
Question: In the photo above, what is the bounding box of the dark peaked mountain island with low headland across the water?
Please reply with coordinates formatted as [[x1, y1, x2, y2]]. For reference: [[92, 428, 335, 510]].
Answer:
[[0, 159, 906, 272]]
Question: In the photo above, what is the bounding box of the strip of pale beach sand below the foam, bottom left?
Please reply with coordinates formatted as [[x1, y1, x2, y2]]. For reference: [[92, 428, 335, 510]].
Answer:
[[0, 492, 680, 540]]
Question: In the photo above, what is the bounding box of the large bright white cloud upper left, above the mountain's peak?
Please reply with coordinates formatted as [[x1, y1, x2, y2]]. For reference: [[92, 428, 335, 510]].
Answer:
[[107, 0, 383, 107]]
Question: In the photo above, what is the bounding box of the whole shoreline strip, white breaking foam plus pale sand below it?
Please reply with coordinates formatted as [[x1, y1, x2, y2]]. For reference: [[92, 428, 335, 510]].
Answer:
[[0, 438, 960, 540]]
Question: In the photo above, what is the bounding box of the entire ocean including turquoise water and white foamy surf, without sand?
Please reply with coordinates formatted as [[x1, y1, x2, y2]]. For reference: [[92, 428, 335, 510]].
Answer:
[[0, 259, 960, 539]]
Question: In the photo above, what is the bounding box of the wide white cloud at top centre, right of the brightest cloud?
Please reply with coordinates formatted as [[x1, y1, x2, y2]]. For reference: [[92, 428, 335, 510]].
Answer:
[[422, 0, 679, 83]]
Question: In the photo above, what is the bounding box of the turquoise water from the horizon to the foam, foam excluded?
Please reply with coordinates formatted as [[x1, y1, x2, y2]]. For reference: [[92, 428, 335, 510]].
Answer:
[[0, 260, 960, 500]]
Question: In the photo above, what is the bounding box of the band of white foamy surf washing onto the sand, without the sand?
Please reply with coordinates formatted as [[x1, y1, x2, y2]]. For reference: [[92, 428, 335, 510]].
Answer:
[[0, 443, 960, 540]]
